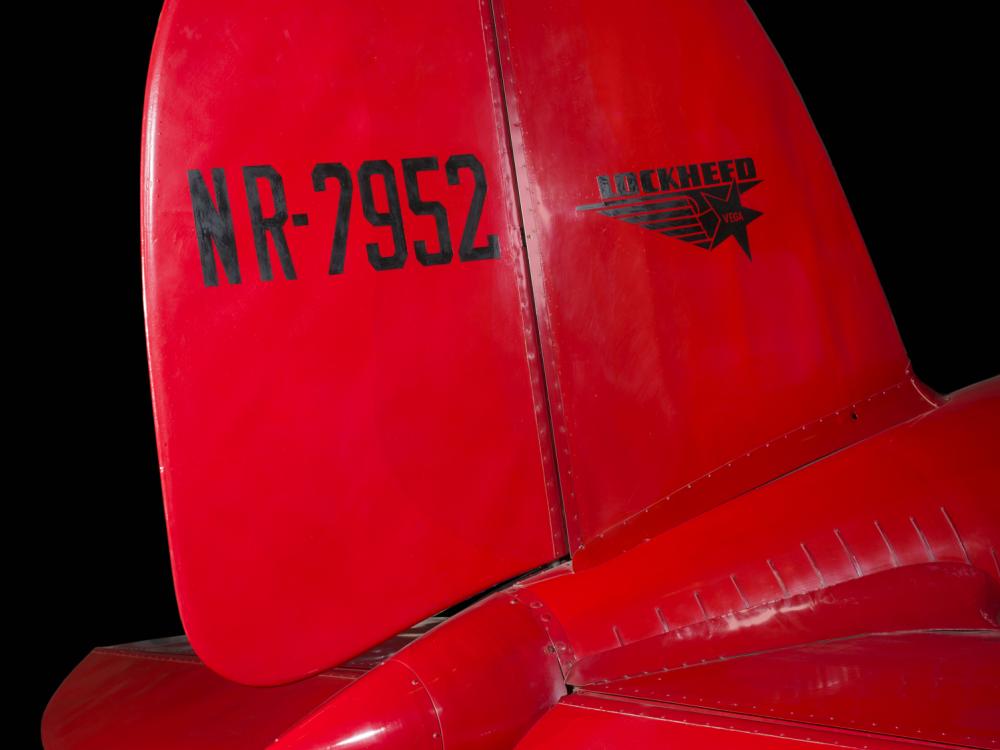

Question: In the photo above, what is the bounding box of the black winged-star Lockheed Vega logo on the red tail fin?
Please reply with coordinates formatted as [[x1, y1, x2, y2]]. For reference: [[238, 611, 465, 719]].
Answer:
[[576, 157, 762, 258]]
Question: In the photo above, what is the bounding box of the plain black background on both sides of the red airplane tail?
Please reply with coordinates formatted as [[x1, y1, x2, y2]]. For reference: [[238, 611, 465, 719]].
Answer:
[[25, 0, 1000, 732]]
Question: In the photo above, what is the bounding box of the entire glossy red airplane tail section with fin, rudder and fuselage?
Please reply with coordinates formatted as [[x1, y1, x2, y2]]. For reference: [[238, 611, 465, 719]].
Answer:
[[43, 0, 1000, 750]]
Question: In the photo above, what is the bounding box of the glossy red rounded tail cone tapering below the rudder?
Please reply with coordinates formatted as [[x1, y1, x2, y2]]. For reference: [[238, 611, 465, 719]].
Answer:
[[277, 592, 566, 750]]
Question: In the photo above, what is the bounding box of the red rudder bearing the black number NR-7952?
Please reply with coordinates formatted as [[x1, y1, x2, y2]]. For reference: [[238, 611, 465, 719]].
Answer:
[[143, 0, 565, 684]]
